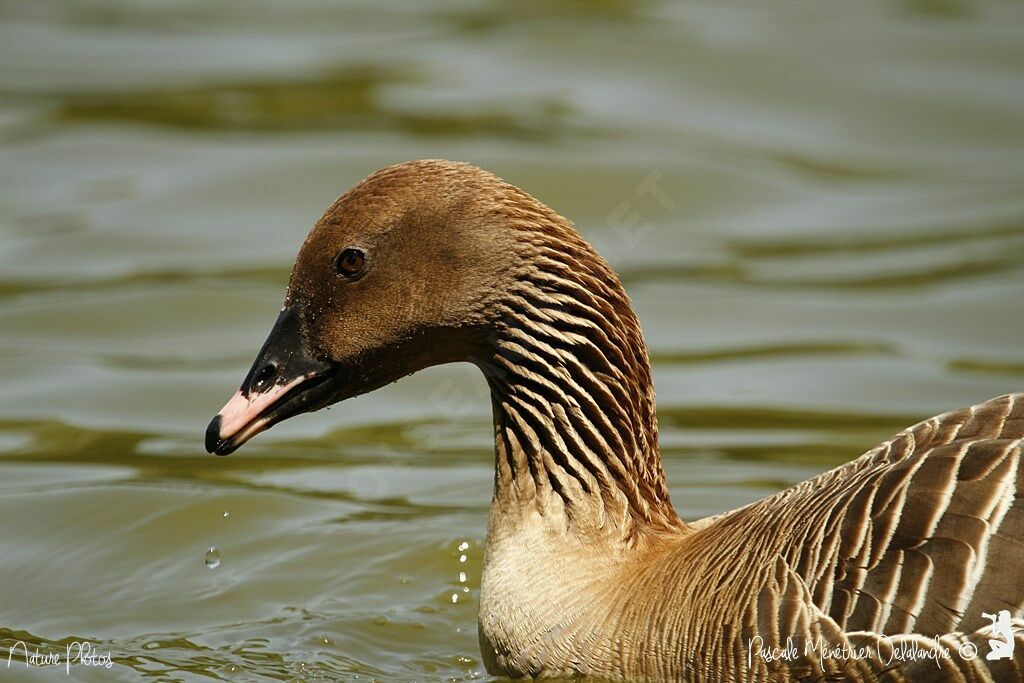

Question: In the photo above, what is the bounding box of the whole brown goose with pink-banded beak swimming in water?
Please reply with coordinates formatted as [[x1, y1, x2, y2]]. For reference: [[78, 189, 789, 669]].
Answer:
[[206, 160, 1024, 681]]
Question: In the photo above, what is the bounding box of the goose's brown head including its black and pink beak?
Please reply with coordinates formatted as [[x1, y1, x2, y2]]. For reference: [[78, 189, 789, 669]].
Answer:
[[206, 161, 555, 455]]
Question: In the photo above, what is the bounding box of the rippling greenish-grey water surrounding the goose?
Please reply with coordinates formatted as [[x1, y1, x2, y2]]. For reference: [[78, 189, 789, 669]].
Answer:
[[0, 0, 1024, 681]]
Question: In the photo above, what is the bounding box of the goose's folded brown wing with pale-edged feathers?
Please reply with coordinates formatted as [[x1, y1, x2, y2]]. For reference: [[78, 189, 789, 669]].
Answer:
[[744, 393, 1024, 636]]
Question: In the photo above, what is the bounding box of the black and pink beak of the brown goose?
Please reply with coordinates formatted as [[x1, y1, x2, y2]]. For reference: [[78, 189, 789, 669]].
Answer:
[[206, 304, 336, 456]]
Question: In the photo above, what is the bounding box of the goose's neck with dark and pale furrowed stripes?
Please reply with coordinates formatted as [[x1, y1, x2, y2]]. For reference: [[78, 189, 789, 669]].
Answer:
[[484, 241, 681, 537]]
